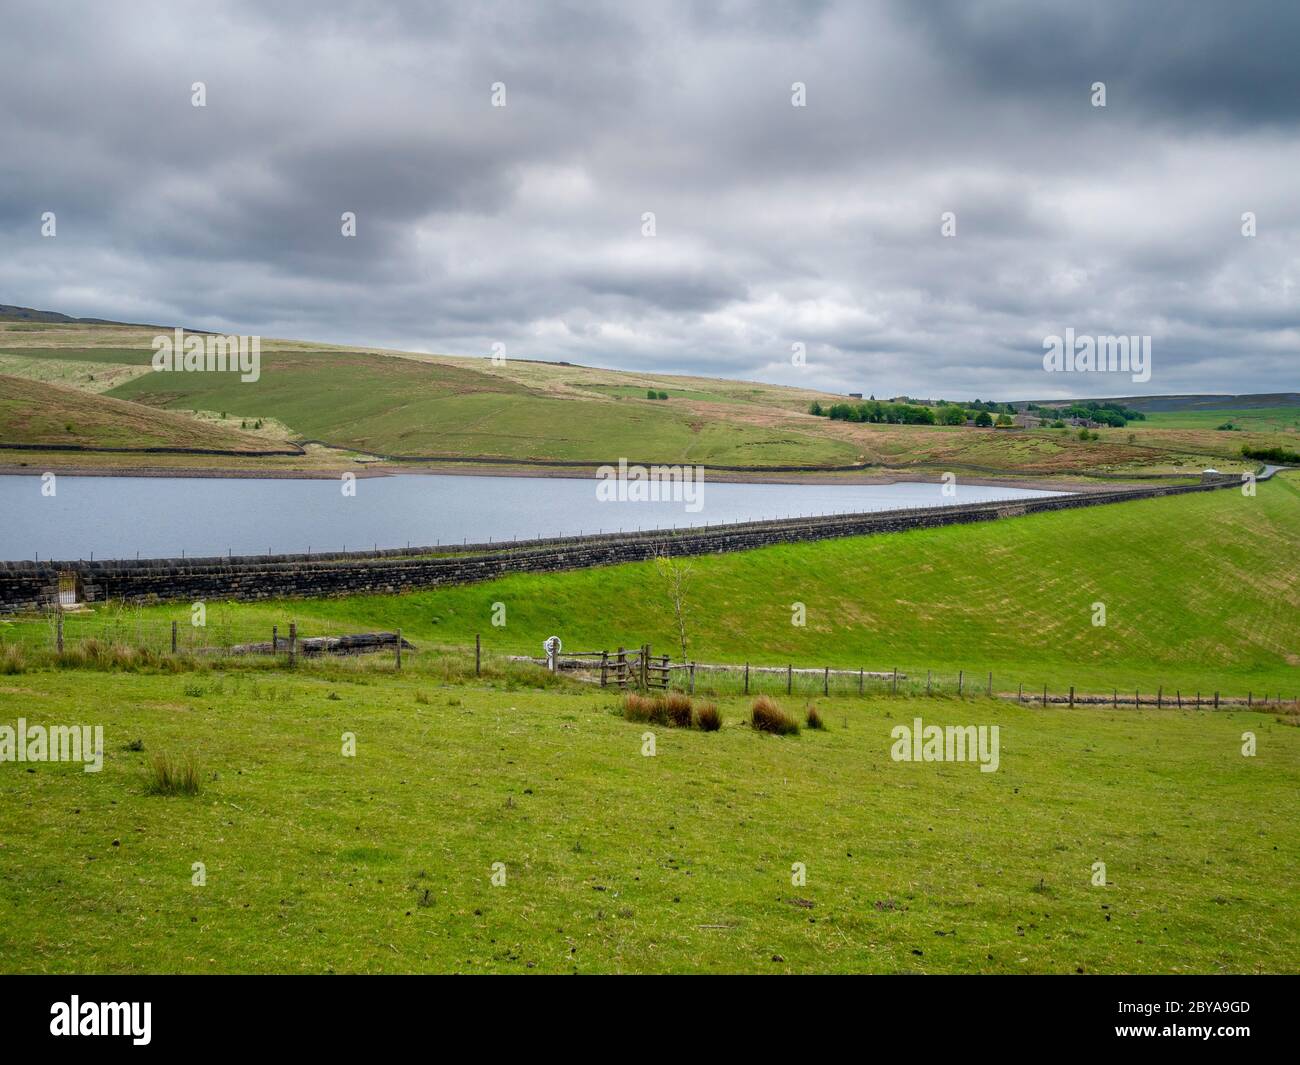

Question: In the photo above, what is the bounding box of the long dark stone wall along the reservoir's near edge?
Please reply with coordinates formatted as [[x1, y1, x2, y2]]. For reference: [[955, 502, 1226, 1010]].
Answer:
[[0, 476, 1242, 614]]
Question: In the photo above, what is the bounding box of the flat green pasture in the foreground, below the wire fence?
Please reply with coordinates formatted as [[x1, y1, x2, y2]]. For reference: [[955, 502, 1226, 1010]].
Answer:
[[0, 667, 1300, 974]]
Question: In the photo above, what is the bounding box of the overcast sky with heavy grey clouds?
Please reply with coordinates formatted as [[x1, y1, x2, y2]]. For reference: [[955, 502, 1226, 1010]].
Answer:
[[0, 0, 1300, 399]]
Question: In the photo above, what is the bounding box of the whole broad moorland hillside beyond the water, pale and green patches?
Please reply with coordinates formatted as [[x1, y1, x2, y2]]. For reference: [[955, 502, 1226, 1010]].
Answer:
[[0, 321, 1294, 476]]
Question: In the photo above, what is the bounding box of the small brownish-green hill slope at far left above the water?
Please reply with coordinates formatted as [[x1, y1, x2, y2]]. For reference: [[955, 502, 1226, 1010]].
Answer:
[[0, 375, 278, 451]]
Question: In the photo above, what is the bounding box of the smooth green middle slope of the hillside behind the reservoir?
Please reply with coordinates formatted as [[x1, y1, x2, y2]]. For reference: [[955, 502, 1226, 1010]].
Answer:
[[104, 351, 855, 464]]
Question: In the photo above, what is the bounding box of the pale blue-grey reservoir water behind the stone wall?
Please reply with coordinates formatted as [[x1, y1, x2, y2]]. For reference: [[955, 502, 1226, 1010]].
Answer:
[[0, 473, 1057, 560]]
